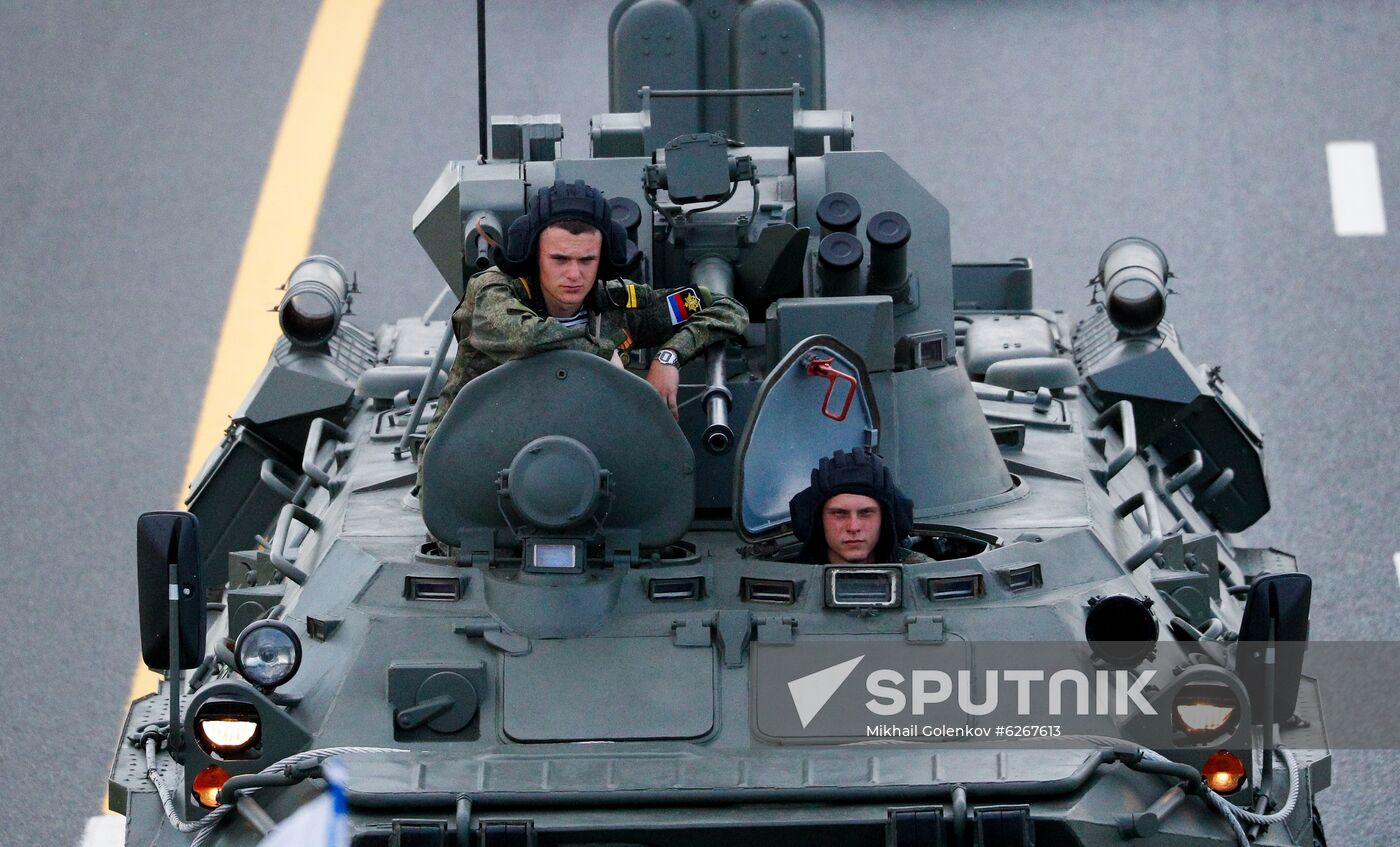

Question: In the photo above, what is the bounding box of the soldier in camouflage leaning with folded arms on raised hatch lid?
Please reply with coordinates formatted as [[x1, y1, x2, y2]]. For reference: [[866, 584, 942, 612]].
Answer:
[[428, 181, 749, 448]]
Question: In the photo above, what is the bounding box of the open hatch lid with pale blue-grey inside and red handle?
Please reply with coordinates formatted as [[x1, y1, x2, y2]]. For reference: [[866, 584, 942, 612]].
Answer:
[[734, 335, 879, 542]]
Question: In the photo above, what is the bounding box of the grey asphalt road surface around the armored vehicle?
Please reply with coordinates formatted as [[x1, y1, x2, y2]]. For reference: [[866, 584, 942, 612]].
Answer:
[[0, 0, 1400, 847]]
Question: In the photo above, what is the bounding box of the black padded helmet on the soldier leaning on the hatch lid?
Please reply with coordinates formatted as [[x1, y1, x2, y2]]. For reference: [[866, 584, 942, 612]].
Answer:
[[494, 179, 641, 281]]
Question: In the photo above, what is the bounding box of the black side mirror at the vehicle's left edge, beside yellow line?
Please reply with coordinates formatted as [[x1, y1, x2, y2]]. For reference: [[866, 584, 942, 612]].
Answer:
[[136, 512, 206, 671]]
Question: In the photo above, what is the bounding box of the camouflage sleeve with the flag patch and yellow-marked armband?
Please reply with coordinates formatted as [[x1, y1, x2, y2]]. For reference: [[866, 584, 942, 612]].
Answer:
[[627, 286, 749, 361]]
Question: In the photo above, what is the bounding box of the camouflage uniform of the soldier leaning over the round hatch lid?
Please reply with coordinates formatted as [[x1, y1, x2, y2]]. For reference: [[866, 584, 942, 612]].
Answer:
[[427, 267, 749, 456]]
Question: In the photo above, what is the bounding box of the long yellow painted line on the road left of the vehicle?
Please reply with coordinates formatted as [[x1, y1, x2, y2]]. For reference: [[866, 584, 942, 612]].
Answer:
[[120, 0, 382, 714]]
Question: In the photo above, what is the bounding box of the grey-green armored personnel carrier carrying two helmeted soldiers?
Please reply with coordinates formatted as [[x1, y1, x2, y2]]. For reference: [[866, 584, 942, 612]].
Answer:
[[109, 0, 1330, 847]]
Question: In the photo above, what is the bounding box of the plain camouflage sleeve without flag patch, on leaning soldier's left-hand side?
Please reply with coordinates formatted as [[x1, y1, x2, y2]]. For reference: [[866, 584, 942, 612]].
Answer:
[[464, 274, 598, 363]]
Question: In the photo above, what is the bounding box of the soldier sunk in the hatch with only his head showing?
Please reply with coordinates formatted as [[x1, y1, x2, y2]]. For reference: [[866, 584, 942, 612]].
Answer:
[[788, 449, 932, 564]]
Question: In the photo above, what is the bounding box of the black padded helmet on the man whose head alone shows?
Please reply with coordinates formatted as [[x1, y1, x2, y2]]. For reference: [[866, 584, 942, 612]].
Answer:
[[788, 449, 914, 564]]
